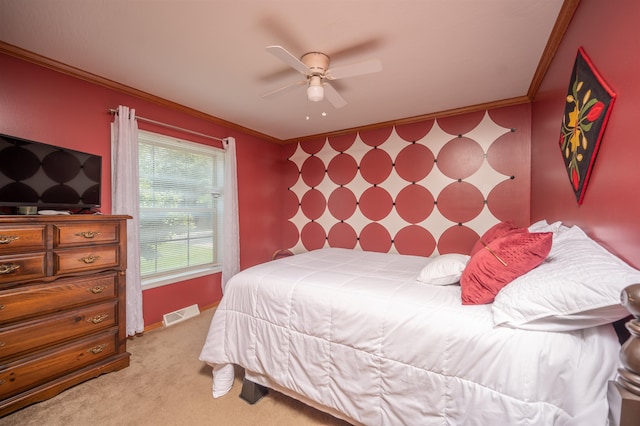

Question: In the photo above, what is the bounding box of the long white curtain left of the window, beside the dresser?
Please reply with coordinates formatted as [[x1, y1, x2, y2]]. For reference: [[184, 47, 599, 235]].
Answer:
[[111, 106, 144, 336]]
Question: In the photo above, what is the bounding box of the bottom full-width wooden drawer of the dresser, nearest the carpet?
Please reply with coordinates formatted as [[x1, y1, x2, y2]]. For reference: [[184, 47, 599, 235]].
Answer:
[[0, 329, 117, 398]]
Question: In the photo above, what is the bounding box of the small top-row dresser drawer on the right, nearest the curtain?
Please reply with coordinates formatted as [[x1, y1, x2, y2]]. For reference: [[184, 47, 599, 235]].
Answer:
[[53, 222, 120, 247]]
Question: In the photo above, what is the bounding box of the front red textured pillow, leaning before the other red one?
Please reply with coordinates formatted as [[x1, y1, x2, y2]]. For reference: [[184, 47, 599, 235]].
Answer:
[[460, 232, 553, 305]]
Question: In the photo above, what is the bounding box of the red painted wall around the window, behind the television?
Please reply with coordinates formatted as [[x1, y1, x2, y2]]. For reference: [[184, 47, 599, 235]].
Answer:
[[0, 54, 282, 326]]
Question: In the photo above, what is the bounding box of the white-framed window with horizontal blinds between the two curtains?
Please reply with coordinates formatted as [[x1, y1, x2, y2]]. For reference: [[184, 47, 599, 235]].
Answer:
[[138, 131, 224, 288]]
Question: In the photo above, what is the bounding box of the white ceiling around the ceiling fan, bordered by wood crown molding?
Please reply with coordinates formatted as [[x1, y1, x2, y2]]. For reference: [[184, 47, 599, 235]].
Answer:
[[0, 0, 563, 140]]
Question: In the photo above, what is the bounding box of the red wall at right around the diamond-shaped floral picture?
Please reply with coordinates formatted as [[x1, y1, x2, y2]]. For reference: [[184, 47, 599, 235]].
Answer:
[[531, 0, 640, 267]]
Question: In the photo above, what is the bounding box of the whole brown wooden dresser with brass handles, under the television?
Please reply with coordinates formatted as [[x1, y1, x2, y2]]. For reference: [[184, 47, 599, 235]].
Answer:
[[0, 215, 129, 416]]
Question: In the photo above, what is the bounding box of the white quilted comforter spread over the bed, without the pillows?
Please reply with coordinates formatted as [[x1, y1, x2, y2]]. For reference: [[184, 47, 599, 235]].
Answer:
[[200, 248, 619, 426]]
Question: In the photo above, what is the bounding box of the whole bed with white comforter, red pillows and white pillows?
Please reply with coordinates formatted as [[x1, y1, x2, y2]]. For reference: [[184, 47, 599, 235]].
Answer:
[[200, 221, 640, 425]]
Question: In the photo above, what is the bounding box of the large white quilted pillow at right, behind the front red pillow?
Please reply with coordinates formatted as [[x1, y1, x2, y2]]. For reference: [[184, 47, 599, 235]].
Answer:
[[492, 226, 640, 331]]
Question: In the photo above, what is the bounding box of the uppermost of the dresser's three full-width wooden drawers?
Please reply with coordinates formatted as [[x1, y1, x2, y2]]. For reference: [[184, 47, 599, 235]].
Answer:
[[0, 272, 117, 325]]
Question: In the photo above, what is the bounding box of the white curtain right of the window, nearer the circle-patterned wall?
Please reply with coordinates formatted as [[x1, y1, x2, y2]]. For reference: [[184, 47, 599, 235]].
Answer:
[[222, 137, 240, 293]]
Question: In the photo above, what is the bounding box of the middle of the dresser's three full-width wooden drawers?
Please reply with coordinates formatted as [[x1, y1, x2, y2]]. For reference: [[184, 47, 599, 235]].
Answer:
[[0, 300, 117, 360]]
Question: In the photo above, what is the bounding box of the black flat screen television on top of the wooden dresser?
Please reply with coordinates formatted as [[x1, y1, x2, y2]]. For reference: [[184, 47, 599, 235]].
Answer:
[[0, 134, 102, 212]]
